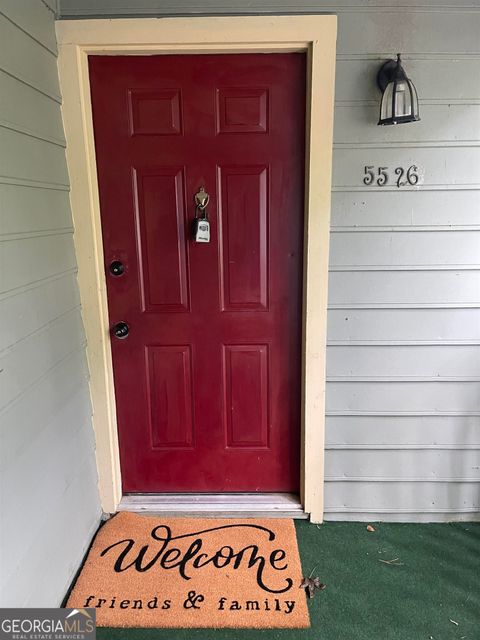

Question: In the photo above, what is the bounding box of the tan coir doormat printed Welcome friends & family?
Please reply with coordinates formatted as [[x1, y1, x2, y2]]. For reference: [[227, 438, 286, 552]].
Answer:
[[66, 513, 310, 628]]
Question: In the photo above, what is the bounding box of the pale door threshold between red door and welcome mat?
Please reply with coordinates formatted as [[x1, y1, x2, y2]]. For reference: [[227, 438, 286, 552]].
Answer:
[[118, 493, 308, 518]]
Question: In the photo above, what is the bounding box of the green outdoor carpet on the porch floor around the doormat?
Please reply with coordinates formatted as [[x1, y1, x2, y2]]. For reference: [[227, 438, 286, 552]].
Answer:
[[97, 521, 480, 640]]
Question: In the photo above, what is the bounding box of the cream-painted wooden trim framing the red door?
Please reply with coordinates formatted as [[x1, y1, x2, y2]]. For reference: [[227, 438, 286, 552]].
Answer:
[[56, 15, 337, 522]]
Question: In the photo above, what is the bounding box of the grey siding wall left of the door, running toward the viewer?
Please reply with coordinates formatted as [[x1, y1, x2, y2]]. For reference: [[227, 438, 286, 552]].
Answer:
[[0, 0, 101, 607]]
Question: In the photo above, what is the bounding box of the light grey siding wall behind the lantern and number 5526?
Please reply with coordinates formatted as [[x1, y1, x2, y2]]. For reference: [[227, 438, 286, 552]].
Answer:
[[60, 0, 480, 521]]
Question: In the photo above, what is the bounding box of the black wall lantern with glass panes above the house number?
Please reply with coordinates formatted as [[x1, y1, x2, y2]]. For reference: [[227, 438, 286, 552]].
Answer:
[[377, 53, 420, 125]]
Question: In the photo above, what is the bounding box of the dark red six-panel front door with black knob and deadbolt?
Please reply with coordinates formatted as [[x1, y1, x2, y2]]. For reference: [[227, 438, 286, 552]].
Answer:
[[90, 53, 306, 492]]
